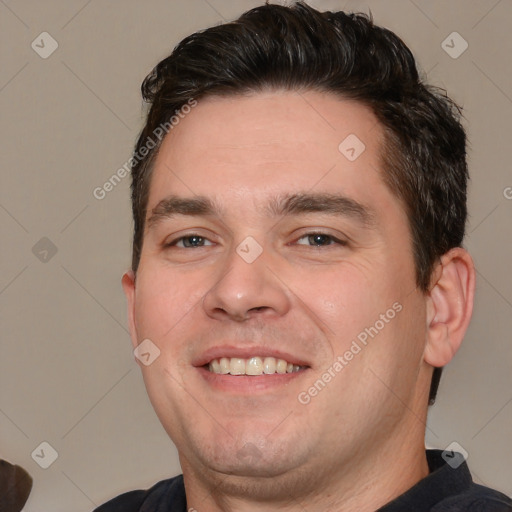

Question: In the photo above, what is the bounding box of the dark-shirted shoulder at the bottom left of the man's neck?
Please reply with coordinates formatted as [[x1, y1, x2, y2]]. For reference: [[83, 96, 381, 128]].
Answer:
[[93, 475, 185, 512]]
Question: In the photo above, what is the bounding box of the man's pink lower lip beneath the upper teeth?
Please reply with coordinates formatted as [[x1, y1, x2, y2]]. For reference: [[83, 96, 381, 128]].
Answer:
[[197, 367, 308, 394]]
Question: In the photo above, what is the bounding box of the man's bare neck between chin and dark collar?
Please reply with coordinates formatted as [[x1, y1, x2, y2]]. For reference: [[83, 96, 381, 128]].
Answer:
[[181, 425, 429, 512]]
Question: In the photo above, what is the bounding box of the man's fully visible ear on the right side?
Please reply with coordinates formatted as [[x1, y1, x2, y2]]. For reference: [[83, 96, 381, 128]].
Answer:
[[423, 247, 475, 368]]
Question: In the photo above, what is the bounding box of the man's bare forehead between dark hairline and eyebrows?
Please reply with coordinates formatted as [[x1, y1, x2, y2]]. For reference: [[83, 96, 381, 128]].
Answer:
[[147, 91, 396, 220]]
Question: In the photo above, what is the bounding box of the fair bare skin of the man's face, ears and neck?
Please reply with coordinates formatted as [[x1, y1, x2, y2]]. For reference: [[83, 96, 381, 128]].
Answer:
[[123, 91, 474, 511]]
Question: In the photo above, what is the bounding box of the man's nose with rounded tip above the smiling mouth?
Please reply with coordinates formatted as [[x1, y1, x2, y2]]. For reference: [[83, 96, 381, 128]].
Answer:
[[203, 243, 290, 322]]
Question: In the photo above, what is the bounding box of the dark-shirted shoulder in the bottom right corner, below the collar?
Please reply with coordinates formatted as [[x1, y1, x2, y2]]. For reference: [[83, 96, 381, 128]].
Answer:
[[432, 483, 512, 512]]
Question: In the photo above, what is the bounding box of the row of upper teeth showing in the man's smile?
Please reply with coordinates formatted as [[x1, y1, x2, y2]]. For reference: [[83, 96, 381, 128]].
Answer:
[[208, 357, 303, 375]]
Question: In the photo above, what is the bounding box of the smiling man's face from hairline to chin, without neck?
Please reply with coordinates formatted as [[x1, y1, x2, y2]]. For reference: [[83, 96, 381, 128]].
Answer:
[[123, 92, 428, 496]]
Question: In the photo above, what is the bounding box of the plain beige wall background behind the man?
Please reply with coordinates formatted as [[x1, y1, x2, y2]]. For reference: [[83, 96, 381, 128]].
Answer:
[[0, 0, 512, 512]]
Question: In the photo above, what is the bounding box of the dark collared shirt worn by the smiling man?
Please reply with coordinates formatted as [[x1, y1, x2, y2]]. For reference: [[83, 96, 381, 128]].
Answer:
[[94, 450, 512, 512]]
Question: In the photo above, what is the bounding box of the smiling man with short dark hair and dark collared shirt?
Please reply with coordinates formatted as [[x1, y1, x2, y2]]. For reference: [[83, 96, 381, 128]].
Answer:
[[97, 3, 512, 512]]
